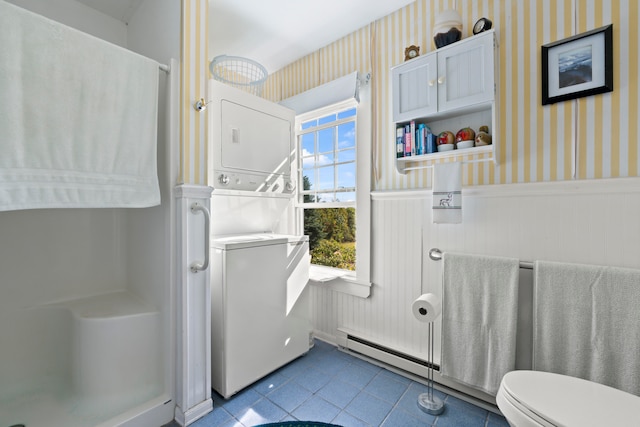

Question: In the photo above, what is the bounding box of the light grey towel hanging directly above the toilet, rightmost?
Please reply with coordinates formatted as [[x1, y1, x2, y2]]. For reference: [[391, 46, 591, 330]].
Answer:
[[533, 261, 640, 396]]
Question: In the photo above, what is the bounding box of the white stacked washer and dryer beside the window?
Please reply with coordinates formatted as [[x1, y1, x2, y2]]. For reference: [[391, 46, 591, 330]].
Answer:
[[207, 80, 311, 398]]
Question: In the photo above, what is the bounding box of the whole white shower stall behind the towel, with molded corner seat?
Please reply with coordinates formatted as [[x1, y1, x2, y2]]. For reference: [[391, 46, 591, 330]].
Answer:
[[0, 0, 180, 427]]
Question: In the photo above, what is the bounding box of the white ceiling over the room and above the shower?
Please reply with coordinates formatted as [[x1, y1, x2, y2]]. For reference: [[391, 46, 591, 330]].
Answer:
[[78, 0, 415, 73]]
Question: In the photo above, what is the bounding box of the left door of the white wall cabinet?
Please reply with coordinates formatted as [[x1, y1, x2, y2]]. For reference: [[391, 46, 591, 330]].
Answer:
[[392, 53, 438, 122]]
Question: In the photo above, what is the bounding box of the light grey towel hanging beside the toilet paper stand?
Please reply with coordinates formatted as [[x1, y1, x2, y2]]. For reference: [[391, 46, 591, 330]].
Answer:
[[440, 253, 520, 396]]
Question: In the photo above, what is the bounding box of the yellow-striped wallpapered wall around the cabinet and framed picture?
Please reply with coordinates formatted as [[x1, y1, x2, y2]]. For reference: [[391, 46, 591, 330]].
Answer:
[[265, 0, 640, 190]]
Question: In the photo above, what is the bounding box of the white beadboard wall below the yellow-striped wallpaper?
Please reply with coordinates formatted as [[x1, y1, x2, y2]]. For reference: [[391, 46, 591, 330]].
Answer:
[[312, 178, 640, 362]]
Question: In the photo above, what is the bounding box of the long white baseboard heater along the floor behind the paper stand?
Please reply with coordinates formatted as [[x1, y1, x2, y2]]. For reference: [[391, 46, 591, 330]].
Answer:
[[335, 328, 497, 412]]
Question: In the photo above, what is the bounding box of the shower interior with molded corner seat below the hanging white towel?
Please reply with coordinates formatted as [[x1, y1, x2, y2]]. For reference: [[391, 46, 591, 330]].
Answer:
[[0, 207, 173, 427]]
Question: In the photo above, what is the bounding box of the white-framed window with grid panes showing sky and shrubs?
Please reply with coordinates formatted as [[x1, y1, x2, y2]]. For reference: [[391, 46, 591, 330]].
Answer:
[[296, 83, 371, 297]]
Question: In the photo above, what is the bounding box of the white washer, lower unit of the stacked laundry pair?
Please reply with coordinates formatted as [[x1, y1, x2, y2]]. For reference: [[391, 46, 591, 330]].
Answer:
[[211, 233, 311, 398]]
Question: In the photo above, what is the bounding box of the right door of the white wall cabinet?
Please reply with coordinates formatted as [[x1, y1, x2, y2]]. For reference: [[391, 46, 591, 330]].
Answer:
[[438, 33, 495, 112]]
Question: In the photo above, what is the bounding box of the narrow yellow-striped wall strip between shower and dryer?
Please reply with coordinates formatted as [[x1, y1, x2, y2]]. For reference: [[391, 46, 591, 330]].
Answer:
[[178, 0, 209, 185]]
